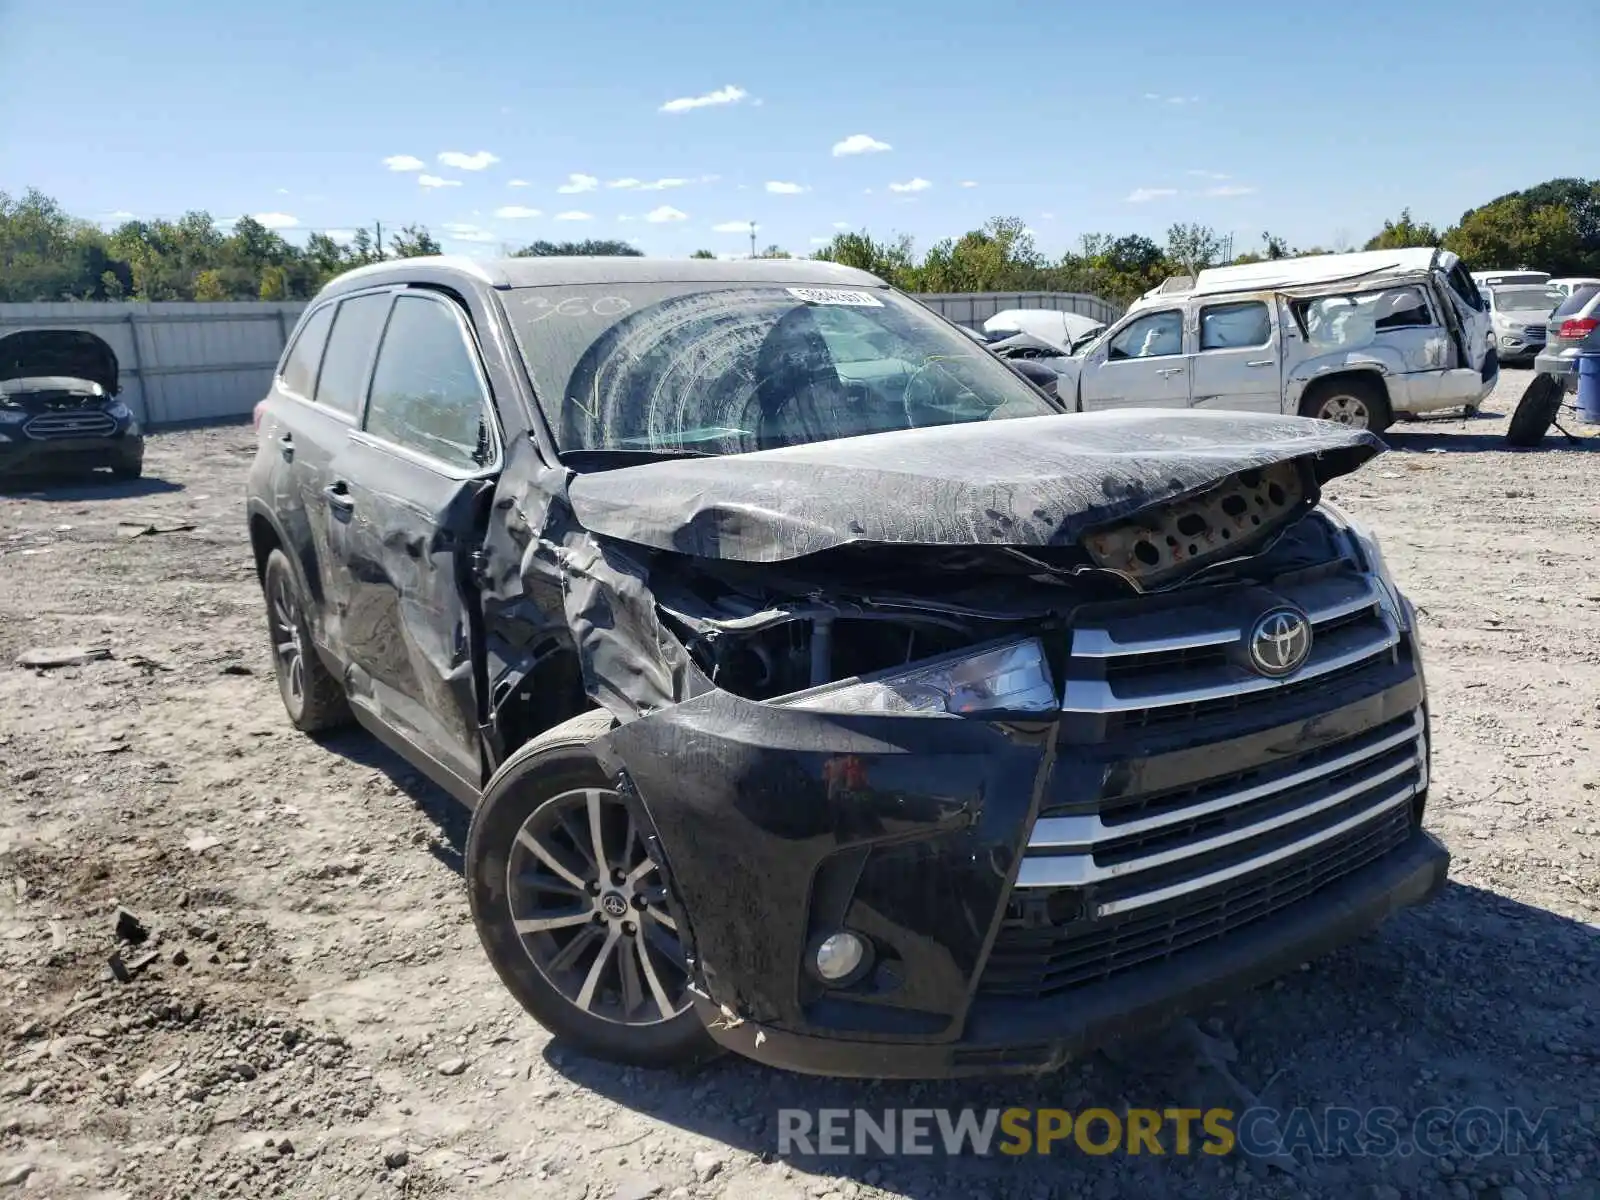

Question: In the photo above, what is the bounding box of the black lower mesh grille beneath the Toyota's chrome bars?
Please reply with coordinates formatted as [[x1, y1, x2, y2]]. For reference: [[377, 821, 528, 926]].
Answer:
[[979, 805, 1411, 998]]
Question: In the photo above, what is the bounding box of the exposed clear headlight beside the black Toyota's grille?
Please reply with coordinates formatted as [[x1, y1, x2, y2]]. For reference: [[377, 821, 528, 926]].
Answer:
[[773, 638, 1059, 717]]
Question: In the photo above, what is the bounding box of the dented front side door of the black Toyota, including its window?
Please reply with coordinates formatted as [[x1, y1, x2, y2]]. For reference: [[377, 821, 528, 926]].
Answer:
[[330, 290, 501, 792]]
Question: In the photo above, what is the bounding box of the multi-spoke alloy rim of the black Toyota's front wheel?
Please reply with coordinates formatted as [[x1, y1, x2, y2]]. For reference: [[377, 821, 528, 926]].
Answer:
[[506, 787, 690, 1026]]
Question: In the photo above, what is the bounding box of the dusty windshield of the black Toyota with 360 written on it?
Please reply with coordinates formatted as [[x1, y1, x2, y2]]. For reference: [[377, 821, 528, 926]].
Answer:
[[506, 283, 1061, 454]]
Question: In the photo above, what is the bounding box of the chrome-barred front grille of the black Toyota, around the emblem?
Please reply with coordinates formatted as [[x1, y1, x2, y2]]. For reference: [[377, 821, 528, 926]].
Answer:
[[1004, 562, 1427, 987]]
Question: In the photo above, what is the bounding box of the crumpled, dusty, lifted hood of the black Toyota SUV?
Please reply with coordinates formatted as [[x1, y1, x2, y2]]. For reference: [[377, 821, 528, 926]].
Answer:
[[568, 410, 1384, 563]]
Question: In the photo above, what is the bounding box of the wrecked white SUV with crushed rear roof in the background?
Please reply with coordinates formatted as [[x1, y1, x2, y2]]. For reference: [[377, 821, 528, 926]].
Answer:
[[1058, 248, 1499, 430]]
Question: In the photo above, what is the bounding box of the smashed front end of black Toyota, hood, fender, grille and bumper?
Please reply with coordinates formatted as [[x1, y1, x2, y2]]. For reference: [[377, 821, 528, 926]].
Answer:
[[485, 413, 1443, 1077]]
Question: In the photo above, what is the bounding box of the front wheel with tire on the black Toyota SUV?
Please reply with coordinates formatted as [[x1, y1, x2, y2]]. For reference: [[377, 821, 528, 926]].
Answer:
[[466, 710, 720, 1069]]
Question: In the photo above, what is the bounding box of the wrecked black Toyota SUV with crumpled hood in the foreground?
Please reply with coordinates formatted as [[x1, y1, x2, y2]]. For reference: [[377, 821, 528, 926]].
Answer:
[[248, 258, 1448, 1077]]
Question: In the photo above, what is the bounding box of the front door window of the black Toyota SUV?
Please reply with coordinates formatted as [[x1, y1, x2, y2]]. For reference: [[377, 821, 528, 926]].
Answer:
[[363, 296, 494, 470]]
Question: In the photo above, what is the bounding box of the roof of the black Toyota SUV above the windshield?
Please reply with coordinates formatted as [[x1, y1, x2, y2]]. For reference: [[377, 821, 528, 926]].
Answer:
[[318, 254, 888, 296]]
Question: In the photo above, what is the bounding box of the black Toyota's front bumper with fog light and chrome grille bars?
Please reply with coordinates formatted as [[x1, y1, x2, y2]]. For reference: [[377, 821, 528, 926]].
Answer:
[[597, 579, 1448, 1077]]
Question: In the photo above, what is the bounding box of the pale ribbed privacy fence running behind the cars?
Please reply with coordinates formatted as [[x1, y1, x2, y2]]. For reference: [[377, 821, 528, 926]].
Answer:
[[0, 291, 1122, 429]]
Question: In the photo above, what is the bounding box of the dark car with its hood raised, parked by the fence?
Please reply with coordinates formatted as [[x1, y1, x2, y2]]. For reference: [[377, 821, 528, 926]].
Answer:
[[0, 330, 144, 478]]
